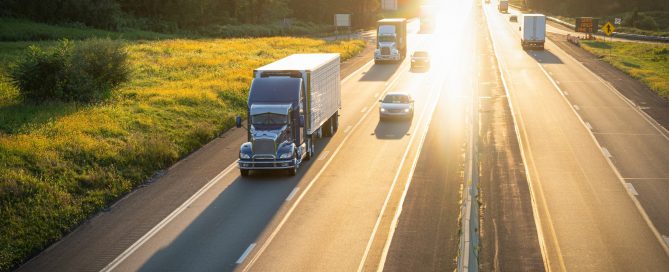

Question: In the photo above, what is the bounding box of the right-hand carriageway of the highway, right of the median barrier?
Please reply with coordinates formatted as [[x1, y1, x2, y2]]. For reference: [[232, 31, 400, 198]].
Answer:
[[486, 1, 669, 271]]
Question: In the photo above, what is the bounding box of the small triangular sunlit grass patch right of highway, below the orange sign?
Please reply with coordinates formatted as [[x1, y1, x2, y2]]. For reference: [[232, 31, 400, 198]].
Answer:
[[581, 40, 669, 100]]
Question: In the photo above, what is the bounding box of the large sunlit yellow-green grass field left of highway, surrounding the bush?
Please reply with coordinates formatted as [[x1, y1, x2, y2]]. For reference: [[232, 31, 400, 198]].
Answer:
[[0, 18, 364, 271]]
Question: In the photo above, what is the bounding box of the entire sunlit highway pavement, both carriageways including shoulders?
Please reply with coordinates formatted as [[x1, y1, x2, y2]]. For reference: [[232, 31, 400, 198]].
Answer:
[[18, 1, 669, 271]]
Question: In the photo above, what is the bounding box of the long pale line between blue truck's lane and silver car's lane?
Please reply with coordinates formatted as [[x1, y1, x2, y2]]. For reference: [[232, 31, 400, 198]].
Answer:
[[242, 57, 406, 271]]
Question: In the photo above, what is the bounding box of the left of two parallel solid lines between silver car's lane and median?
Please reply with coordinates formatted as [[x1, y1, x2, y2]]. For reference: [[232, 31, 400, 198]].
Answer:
[[357, 68, 441, 271]]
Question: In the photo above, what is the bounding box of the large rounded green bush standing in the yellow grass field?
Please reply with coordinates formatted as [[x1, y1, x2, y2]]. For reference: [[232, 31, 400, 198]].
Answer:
[[10, 39, 130, 102]]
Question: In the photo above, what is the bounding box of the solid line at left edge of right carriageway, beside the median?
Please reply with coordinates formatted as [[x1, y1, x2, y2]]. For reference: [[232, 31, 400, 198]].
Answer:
[[484, 4, 552, 271]]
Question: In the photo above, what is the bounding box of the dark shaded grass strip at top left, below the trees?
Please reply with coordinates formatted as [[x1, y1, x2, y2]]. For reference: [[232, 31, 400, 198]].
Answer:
[[0, 17, 177, 41]]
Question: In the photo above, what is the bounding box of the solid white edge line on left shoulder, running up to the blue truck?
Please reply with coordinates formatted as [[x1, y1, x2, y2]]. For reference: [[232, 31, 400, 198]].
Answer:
[[100, 162, 237, 272]]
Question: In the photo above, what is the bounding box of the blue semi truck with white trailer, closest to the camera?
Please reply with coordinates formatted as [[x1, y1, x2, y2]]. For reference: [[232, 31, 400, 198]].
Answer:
[[237, 54, 341, 176]]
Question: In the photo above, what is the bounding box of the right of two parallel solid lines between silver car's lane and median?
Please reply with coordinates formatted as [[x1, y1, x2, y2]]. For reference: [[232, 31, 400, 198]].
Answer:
[[374, 78, 441, 272]]
